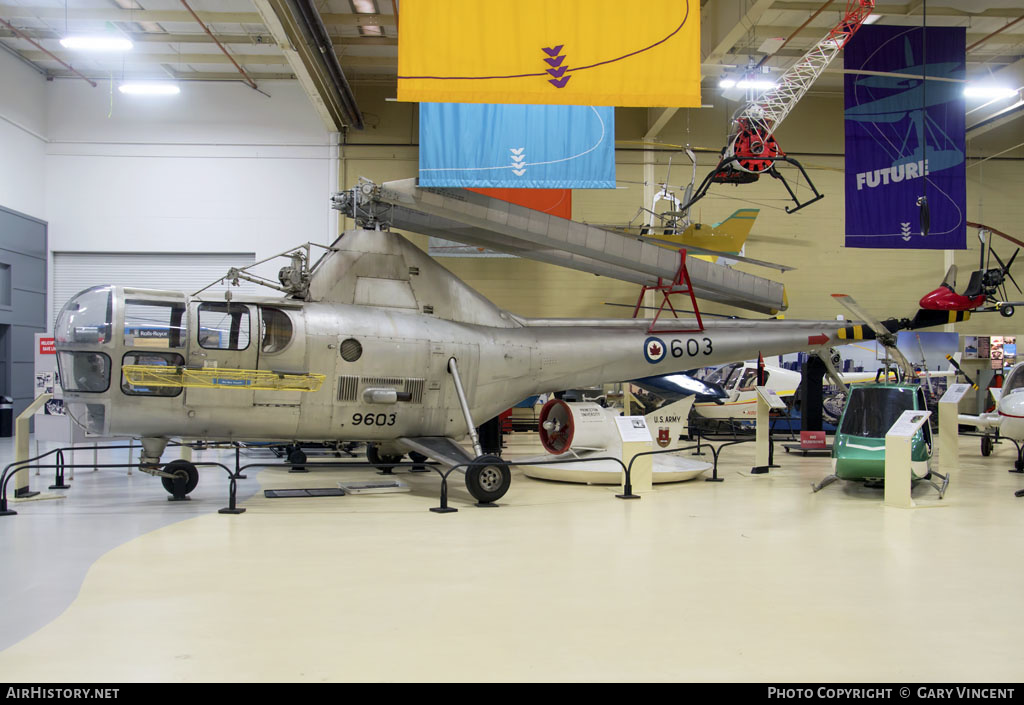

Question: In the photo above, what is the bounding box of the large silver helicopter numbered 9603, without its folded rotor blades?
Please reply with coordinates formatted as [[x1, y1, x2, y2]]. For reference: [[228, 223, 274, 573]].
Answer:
[[54, 181, 966, 502]]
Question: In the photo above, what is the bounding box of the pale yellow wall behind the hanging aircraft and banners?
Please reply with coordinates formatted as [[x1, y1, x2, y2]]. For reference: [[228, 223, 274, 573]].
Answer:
[[340, 86, 1024, 335]]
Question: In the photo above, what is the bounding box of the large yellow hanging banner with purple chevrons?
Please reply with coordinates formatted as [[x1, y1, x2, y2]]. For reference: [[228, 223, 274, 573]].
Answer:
[[398, 0, 700, 108]]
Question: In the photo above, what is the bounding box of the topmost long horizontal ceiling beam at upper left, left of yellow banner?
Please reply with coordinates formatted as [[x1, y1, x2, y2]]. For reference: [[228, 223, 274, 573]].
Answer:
[[0, 5, 394, 27]]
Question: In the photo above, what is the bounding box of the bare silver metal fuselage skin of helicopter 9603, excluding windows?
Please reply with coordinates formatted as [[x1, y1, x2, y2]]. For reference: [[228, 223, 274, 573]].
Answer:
[[66, 286, 837, 441]]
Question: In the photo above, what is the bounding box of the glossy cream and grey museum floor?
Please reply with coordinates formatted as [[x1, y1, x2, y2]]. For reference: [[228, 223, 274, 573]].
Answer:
[[0, 437, 1024, 682]]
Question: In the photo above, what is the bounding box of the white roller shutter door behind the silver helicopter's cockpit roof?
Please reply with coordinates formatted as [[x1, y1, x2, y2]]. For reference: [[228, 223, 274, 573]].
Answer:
[[50, 252, 258, 323]]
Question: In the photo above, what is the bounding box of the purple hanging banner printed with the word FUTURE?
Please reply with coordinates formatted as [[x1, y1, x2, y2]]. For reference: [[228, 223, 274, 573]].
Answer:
[[844, 25, 967, 250]]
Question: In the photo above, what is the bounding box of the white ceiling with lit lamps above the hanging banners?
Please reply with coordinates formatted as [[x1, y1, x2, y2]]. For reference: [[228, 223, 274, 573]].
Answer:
[[0, 0, 1024, 91]]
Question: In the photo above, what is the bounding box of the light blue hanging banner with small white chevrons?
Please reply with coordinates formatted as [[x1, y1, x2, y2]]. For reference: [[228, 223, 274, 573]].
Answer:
[[420, 102, 615, 189]]
